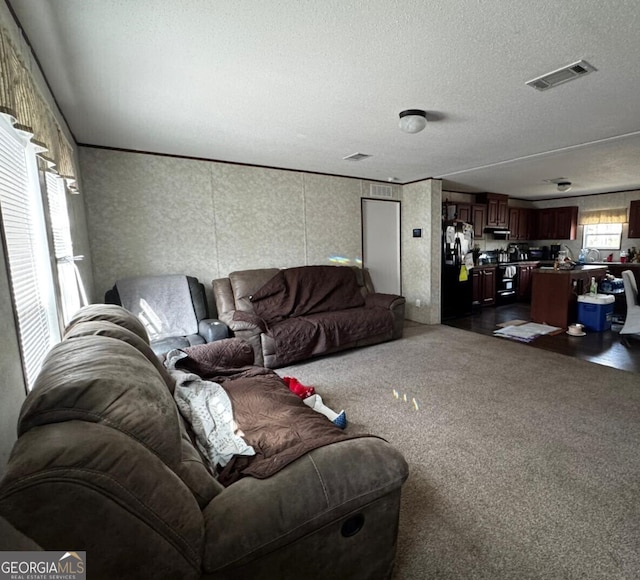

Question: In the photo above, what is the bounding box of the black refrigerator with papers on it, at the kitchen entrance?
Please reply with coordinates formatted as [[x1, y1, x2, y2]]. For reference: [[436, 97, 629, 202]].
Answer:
[[440, 220, 473, 320]]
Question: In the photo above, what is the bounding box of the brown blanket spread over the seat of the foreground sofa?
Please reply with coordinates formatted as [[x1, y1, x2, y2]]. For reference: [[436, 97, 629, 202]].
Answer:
[[176, 343, 369, 486]]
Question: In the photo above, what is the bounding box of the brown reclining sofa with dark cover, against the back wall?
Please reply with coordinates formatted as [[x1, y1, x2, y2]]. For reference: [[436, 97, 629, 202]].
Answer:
[[213, 266, 405, 368]]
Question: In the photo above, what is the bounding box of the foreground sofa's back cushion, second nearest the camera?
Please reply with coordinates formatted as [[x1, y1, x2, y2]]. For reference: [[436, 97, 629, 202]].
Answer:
[[18, 336, 181, 467]]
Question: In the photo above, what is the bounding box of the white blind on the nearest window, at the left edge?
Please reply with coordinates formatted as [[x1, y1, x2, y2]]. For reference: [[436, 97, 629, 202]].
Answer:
[[0, 116, 59, 389]]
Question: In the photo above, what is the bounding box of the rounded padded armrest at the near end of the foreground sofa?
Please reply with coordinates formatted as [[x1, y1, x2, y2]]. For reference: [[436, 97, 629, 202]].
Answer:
[[203, 437, 408, 578]]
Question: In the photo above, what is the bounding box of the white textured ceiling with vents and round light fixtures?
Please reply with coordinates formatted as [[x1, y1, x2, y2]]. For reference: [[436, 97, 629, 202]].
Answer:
[[8, 0, 640, 200]]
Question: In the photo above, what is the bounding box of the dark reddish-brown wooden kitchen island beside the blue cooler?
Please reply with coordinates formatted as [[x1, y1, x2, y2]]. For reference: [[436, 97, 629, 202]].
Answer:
[[531, 265, 607, 328]]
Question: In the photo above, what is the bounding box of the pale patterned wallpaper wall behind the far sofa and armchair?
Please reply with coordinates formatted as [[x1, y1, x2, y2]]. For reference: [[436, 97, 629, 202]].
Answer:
[[80, 147, 420, 314]]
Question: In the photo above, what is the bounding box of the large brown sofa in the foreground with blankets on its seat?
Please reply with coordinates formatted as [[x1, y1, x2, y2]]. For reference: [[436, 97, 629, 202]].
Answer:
[[0, 305, 407, 580]]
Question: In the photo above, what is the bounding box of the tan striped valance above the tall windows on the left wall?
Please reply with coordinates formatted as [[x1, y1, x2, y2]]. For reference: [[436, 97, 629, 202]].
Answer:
[[0, 27, 76, 189]]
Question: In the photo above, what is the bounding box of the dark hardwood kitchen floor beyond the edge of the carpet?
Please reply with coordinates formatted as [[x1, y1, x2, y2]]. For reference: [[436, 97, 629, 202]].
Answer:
[[442, 302, 640, 373]]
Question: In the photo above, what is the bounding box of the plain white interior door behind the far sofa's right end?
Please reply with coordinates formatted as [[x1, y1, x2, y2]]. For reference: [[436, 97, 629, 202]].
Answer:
[[362, 198, 402, 294]]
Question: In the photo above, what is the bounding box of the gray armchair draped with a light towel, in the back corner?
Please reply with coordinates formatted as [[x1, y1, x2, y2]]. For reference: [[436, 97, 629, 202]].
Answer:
[[104, 275, 229, 355]]
